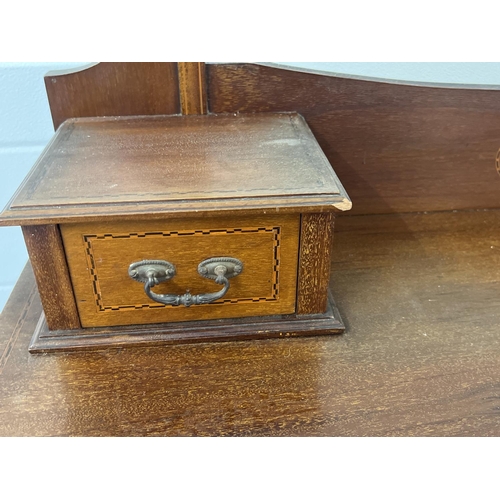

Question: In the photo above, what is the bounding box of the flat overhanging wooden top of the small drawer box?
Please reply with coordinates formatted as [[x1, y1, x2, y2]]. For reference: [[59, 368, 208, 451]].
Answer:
[[0, 113, 351, 225]]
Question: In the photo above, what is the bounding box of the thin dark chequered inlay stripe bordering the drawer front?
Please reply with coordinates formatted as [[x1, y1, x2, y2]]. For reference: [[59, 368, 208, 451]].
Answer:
[[83, 226, 281, 312]]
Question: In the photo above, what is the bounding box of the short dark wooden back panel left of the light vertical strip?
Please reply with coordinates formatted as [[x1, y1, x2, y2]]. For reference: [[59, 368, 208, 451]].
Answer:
[[45, 62, 180, 129]]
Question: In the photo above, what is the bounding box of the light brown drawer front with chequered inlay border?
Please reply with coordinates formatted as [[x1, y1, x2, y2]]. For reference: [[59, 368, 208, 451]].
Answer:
[[61, 214, 300, 327]]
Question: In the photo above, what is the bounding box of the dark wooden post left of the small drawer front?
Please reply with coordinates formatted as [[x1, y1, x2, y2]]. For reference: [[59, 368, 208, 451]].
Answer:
[[22, 225, 80, 330]]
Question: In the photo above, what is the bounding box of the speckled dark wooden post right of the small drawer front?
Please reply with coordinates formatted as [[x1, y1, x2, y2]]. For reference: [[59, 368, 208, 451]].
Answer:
[[297, 213, 334, 314]]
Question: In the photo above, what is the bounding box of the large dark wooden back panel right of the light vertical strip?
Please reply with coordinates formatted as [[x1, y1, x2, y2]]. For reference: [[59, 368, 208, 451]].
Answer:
[[207, 64, 500, 215]]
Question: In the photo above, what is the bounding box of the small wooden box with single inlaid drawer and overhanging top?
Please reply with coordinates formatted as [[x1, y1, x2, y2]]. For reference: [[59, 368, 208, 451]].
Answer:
[[0, 113, 351, 352]]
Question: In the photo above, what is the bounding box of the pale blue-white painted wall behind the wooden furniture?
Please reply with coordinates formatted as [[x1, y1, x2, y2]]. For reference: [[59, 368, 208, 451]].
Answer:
[[0, 63, 500, 310]]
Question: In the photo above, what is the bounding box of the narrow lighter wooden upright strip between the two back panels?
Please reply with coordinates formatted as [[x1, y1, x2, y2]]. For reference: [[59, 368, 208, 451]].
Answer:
[[177, 62, 207, 115]]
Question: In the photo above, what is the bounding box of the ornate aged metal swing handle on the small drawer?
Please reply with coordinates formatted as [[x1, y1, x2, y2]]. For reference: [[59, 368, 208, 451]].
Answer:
[[128, 257, 243, 307]]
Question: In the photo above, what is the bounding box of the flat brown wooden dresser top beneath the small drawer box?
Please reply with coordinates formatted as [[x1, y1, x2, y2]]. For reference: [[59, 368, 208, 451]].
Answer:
[[0, 211, 500, 436]]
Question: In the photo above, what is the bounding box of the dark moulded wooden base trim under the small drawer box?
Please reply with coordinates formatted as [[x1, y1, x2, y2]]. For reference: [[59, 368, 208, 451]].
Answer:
[[29, 296, 345, 353]]
